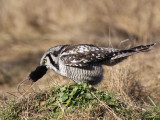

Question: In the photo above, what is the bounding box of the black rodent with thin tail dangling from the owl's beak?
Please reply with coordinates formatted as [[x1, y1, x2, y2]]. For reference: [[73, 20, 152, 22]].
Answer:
[[17, 66, 47, 94]]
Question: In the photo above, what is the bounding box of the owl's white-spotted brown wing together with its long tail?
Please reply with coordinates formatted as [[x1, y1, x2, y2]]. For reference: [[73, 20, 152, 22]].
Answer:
[[60, 43, 156, 67]]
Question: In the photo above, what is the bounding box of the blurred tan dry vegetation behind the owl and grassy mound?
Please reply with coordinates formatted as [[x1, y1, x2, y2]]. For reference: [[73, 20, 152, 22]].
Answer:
[[0, 0, 160, 107]]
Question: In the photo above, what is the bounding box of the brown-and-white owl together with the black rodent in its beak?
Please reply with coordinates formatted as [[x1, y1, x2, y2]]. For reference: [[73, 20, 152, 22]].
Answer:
[[17, 43, 156, 94]]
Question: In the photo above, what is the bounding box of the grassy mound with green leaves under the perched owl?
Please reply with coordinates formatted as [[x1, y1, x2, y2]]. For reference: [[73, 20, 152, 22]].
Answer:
[[0, 84, 160, 120]]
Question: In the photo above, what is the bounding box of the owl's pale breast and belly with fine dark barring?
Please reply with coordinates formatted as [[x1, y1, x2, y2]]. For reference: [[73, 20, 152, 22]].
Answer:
[[57, 62, 103, 85]]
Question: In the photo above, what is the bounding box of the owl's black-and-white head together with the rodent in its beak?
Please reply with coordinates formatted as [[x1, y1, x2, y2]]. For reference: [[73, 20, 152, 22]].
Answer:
[[17, 45, 66, 94]]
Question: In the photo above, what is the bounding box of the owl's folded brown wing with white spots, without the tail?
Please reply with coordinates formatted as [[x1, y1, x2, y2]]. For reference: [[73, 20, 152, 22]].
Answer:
[[60, 44, 116, 67]]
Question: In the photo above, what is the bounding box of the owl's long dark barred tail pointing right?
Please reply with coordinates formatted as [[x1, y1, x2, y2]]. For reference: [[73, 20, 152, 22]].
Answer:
[[105, 43, 156, 66]]
